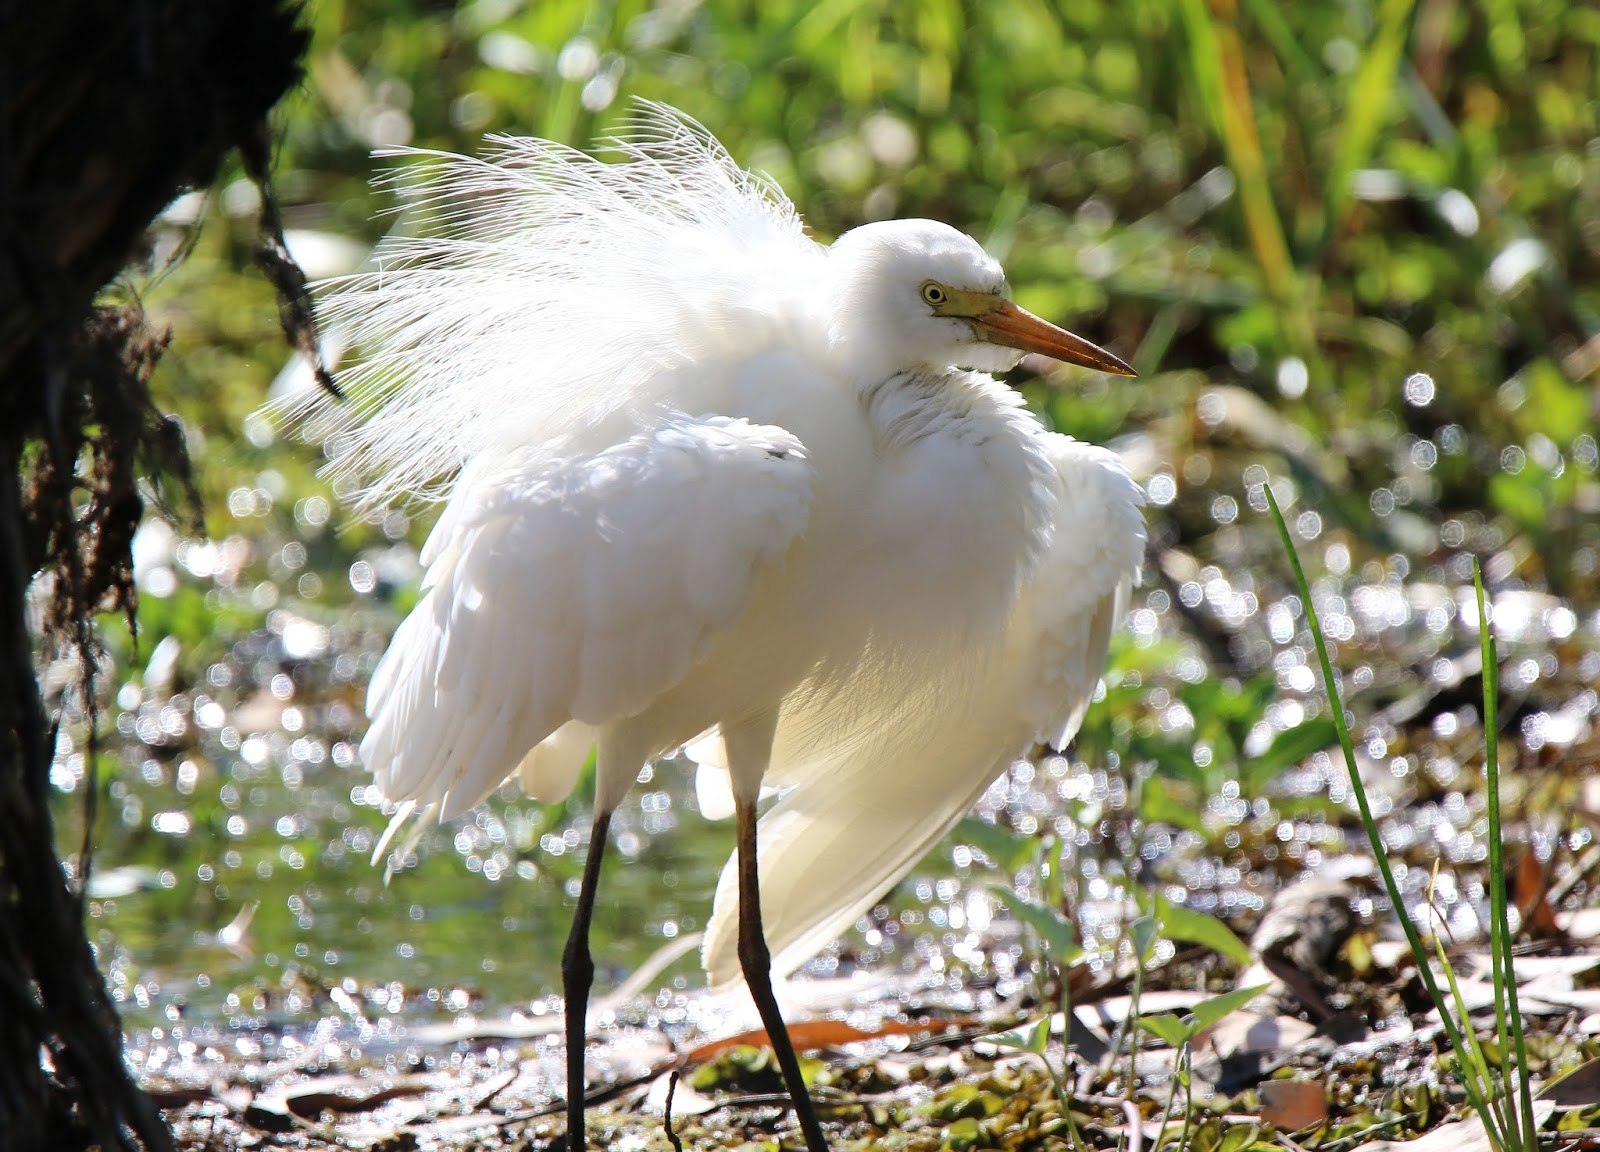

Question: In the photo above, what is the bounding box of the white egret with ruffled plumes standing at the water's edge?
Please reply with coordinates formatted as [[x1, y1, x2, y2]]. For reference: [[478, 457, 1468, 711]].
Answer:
[[297, 106, 1144, 1152]]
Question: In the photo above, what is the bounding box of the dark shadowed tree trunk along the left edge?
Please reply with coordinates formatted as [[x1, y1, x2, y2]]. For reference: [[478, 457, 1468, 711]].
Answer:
[[0, 0, 306, 1150]]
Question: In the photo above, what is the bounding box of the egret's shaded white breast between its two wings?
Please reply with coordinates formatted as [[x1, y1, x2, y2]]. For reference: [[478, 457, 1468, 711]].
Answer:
[[620, 349, 1056, 742]]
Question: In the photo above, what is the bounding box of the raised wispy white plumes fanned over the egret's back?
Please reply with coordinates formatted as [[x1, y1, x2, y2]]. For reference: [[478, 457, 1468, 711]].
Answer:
[[286, 102, 822, 509]]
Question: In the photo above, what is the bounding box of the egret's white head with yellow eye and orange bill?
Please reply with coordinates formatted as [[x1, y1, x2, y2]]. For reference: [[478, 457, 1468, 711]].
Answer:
[[829, 219, 1134, 378]]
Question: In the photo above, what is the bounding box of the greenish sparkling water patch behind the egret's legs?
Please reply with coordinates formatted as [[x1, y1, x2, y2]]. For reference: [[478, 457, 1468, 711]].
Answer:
[[72, 716, 730, 1022]]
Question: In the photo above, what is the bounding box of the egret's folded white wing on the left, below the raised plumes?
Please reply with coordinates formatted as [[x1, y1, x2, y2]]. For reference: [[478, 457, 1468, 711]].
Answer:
[[362, 416, 813, 819]]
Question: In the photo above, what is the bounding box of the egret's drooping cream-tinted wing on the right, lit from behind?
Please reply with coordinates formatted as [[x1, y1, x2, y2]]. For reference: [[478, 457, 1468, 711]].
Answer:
[[702, 435, 1144, 986]]
